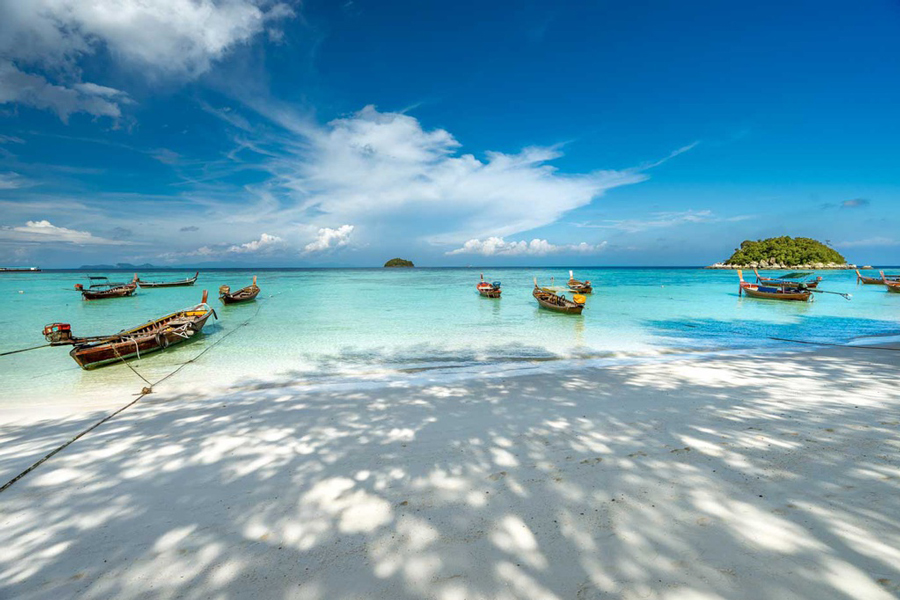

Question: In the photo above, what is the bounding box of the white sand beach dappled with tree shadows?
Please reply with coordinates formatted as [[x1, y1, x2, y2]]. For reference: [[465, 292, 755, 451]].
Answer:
[[0, 348, 900, 600]]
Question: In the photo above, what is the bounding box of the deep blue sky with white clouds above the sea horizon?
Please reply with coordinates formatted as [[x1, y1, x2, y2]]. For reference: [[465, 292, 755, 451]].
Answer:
[[0, 0, 900, 268]]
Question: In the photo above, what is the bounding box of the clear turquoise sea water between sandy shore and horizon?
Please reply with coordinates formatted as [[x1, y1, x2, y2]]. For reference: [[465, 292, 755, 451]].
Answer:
[[0, 268, 900, 403]]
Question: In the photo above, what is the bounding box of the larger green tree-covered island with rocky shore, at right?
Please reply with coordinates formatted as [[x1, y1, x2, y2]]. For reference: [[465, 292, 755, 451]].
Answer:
[[707, 236, 856, 269]]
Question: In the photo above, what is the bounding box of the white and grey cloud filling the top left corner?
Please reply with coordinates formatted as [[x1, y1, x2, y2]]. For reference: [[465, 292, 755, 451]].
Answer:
[[0, 0, 294, 120]]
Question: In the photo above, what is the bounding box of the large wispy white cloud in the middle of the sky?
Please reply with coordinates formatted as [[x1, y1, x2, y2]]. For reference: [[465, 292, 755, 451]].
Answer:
[[255, 106, 658, 244]]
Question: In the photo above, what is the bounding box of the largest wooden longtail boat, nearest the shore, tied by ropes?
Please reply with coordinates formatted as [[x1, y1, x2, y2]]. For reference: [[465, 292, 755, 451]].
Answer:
[[44, 290, 218, 370]]
